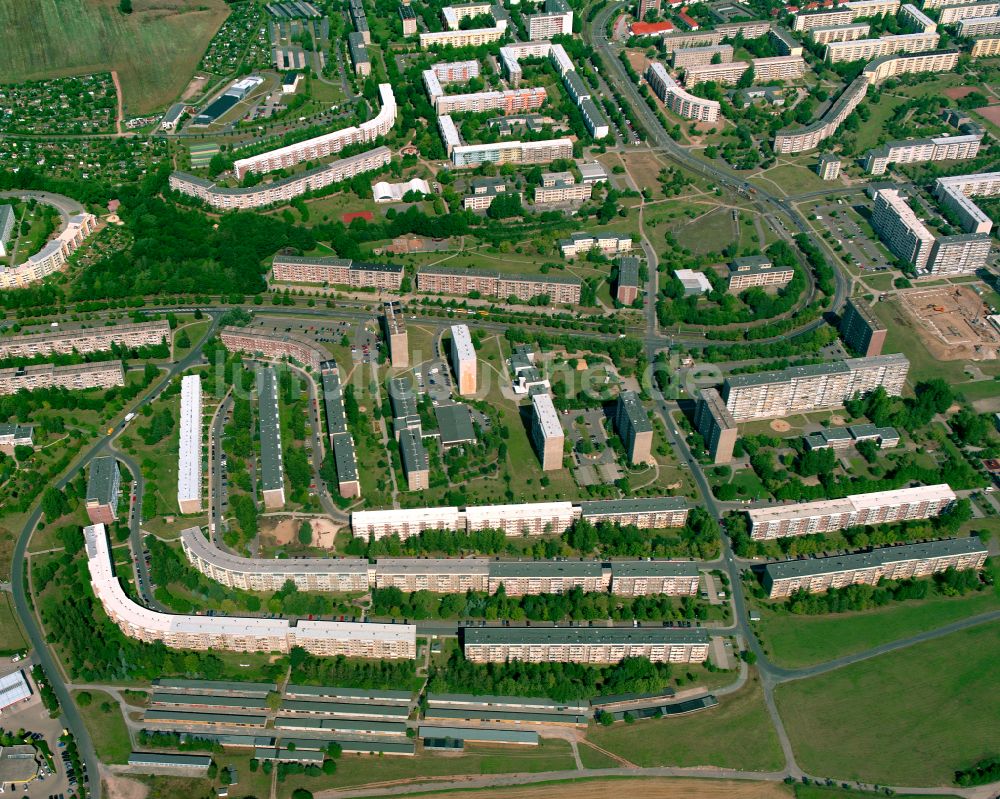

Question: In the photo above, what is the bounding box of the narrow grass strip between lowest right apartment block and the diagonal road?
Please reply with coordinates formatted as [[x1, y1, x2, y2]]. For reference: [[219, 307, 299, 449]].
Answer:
[[759, 592, 1000, 668]]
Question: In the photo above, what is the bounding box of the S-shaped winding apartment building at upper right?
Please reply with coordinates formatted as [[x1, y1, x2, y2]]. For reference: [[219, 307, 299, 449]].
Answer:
[[774, 50, 959, 153]]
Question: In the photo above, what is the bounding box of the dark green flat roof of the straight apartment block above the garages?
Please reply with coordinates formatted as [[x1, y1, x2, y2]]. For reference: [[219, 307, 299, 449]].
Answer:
[[465, 627, 708, 646]]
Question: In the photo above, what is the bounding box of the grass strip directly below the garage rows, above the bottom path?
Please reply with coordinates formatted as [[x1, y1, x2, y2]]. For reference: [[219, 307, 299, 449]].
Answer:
[[278, 738, 575, 799]]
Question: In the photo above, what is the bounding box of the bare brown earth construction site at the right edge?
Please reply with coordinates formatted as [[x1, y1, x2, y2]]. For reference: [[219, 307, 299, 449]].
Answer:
[[897, 285, 1000, 361]]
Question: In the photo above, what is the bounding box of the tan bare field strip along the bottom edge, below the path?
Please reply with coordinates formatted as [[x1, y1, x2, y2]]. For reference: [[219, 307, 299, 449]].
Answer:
[[394, 777, 791, 799]]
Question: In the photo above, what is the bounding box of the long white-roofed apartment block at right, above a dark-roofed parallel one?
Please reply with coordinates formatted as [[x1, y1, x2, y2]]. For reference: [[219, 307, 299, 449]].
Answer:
[[747, 483, 957, 541]]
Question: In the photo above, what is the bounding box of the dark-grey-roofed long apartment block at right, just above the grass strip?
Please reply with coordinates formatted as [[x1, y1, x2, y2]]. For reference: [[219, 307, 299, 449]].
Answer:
[[763, 536, 989, 599]]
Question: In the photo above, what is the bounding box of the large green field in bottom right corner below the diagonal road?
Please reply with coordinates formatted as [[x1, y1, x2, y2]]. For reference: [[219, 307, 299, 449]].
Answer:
[[776, 624, 1000, 786]]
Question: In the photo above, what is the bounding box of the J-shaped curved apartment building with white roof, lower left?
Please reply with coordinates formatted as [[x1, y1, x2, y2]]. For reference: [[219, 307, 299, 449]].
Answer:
[[83, 524, 417, 660]]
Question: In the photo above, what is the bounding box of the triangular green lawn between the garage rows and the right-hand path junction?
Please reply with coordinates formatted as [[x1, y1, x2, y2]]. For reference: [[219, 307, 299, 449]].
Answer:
[[587, 677, 784, 771]]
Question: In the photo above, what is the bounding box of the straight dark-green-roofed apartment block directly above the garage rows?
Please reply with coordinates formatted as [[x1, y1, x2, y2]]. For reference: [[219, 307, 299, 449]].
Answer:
[[463, 627, 709, 663]]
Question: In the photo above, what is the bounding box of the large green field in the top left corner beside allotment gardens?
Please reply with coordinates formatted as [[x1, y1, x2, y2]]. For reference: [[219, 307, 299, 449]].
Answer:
[[0, 0, 229, 116]]
